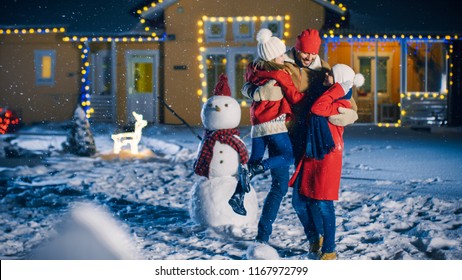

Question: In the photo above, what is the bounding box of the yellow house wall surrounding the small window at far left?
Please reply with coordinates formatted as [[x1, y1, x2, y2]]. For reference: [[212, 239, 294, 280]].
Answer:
[[0, 34, 81, 124]]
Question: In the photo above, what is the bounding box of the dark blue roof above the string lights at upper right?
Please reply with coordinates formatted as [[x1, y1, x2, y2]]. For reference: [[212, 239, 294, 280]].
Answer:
[[340, 0, 462, 35]]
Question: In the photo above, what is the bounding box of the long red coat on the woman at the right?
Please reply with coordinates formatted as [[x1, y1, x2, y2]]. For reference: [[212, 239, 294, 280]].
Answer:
[[289, 83, 351, 200]]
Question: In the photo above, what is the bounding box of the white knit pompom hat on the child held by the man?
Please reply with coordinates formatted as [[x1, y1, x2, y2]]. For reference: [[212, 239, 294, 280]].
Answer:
[[257, 28, 286, 61]]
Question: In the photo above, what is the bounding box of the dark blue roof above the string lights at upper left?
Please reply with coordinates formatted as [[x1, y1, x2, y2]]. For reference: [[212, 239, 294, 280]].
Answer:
[[0, 0, 148, 36]]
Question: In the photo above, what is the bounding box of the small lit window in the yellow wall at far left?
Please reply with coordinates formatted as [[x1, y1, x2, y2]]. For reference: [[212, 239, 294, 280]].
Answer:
[[34, 50, 56, 86]]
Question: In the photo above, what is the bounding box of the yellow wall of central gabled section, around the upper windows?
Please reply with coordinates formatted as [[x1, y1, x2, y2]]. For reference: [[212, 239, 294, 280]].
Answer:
[[164, 0, 324, 125]]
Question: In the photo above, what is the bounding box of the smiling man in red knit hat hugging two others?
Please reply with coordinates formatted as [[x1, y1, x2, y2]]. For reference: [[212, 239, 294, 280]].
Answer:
[[242, 29, 358, 260]]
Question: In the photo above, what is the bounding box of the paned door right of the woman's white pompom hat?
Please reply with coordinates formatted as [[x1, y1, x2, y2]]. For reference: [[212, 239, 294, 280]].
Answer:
[[354, 53, 397, 123]]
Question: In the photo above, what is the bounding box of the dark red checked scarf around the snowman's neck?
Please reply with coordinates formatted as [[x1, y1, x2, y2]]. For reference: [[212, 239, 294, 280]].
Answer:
[[194, 128, 249, 178]]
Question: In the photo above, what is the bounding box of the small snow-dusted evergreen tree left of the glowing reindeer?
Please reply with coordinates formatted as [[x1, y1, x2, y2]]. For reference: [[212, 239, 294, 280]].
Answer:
[[63, 106, 96, 156]]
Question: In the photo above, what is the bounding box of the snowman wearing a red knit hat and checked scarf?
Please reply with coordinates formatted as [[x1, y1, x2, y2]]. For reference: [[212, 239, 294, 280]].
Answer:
[[190, 74, 258, 228]]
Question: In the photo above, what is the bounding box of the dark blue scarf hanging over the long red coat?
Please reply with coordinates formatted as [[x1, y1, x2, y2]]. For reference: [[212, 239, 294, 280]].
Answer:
[[305, 89, 353, 160]]
